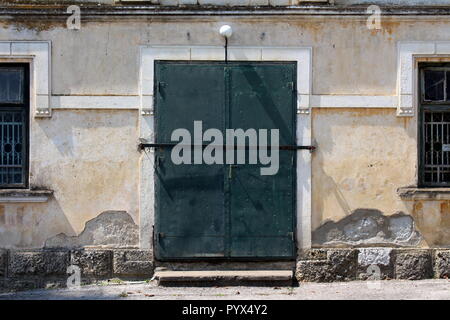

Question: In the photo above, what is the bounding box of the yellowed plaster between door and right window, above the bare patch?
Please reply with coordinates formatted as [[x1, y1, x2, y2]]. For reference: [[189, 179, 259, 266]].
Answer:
[[312, 109, 417, 228]]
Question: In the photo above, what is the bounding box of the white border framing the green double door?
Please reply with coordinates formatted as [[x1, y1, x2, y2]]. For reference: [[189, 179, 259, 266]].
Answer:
[[139, 46, 312, 250]]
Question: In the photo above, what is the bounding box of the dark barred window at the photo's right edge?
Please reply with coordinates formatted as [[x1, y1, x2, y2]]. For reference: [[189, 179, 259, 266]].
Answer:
[[419, 64, 450, 187]]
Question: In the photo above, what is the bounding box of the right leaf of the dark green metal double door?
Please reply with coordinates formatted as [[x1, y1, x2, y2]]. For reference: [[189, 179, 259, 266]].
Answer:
[[229, 65, 295, 257]]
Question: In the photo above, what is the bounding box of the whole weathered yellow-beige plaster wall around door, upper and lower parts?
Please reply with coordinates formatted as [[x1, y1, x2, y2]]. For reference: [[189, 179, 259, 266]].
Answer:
[[0, 17, 450, 247]]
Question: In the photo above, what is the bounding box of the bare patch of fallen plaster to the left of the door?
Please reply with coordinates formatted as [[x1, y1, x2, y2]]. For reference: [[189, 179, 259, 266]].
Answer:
[[44, 211, 139, 248]]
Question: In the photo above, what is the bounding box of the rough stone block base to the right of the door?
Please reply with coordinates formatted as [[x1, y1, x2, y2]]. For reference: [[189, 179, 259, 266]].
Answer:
[[296, 248, 450, 282]]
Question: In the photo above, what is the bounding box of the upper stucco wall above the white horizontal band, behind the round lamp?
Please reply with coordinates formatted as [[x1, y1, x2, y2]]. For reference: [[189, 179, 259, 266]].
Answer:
[[0, 17, 449, 95]]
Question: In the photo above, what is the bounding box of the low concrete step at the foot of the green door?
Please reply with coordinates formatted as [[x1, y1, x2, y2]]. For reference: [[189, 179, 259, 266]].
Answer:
[[155, 270, 294, 286]]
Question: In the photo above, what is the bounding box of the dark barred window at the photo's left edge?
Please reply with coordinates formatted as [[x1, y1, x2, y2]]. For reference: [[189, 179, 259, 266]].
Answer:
[[0, 64, 29, 188]]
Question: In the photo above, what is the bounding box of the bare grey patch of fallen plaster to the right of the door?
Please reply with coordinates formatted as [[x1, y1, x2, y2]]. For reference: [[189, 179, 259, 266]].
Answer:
[[312, 209, 422, 246]]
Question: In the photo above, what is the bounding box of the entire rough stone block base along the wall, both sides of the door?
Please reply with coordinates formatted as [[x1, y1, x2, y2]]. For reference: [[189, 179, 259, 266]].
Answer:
[[0, 247, 450, 291]]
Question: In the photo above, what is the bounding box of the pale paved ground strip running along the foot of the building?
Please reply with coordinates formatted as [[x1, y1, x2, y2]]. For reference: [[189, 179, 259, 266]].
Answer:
[[0, 280, 450, 300]]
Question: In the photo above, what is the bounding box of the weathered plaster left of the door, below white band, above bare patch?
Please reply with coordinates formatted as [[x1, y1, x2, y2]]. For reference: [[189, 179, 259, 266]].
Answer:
[[0, 110, 139, 248]]
